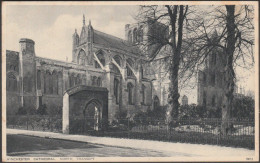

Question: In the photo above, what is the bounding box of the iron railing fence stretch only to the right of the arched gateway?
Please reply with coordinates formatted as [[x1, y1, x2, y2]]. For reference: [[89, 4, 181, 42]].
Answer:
[[72, 118, 255, 149]]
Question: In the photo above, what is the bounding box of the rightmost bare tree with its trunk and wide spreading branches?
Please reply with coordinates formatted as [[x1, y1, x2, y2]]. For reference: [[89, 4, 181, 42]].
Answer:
[[187, 5, 254, 134]]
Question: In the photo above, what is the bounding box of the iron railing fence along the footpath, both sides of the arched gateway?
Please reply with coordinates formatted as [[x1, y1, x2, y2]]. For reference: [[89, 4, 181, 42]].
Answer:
[[7, 116, 255, 149]]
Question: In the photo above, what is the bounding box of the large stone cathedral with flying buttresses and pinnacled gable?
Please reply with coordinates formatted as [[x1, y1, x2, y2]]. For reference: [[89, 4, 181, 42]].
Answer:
[[6, 16, 169, 120]]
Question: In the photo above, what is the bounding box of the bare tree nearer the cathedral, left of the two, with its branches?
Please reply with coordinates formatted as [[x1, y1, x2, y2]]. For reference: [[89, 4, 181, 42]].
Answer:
[[137, 5, 188, 117]]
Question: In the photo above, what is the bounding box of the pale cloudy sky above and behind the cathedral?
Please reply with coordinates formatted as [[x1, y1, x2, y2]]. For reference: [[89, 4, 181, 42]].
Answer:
[[3, 5, 254, 103]]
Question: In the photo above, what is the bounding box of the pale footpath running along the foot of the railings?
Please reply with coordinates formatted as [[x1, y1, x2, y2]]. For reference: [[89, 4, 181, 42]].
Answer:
[[6, 129, 255, 158]]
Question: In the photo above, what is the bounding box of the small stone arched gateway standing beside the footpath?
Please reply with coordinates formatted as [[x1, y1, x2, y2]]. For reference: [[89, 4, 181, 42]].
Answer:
[[62, 85, 108, 134]]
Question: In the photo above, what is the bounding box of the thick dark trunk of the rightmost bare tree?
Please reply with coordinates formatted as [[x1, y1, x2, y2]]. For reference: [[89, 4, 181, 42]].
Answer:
[[221, 5, 236, 135]]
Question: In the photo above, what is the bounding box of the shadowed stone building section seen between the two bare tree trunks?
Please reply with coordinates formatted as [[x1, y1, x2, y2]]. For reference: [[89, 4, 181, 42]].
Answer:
[[197, 31, 226, 110]]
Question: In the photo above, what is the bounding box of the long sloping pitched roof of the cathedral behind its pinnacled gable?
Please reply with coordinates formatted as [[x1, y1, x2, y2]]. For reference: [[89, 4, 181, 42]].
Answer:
[[93, 30, 141, 55]]
